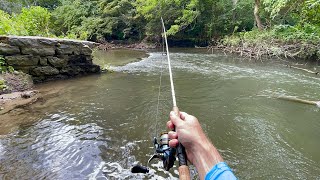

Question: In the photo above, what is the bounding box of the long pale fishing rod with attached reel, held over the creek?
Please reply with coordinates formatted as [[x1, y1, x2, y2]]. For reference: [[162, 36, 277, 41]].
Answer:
[[131, 17, 190, 180]]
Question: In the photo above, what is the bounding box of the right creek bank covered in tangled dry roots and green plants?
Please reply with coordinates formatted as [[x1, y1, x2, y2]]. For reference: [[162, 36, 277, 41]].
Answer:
[[215, 30, 320, 63]]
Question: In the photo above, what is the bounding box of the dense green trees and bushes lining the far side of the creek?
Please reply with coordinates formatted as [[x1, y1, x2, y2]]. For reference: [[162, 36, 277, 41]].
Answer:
[[0, 0, 320, 59]]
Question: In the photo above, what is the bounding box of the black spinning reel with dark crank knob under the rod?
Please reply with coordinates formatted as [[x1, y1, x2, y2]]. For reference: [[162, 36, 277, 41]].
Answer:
[[131, 133, 176, 174]]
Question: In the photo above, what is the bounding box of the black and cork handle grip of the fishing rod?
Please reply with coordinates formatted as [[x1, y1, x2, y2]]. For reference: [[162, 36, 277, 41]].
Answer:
[[172, 106, 191, 180]]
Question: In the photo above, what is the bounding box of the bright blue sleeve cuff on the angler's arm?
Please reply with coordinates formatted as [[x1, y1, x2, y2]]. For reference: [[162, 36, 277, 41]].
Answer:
[[205, 162, 237, 180]]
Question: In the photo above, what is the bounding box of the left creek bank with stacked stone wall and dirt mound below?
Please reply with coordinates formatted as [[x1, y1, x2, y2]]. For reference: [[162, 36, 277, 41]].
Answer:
[[0, 36, 101, 116]]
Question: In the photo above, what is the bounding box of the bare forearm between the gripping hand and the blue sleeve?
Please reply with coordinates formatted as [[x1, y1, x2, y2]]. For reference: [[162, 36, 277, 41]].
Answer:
[[194, 137, 223, 179]]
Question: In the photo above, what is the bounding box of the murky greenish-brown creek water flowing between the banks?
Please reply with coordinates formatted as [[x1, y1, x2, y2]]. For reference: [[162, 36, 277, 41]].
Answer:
[[0, 50, 320, 179]]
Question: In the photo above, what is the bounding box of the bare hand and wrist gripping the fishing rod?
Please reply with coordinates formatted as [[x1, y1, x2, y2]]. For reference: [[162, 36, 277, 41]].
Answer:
[[167, 111, 223, 179]]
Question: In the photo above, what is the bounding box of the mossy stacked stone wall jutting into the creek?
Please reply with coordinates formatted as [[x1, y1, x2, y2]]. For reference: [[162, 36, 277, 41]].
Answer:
[[0, 36, 100, 82]]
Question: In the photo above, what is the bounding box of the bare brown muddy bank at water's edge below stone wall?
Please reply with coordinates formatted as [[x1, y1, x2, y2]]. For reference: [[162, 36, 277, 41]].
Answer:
[[0, 82, 65, 135]]
